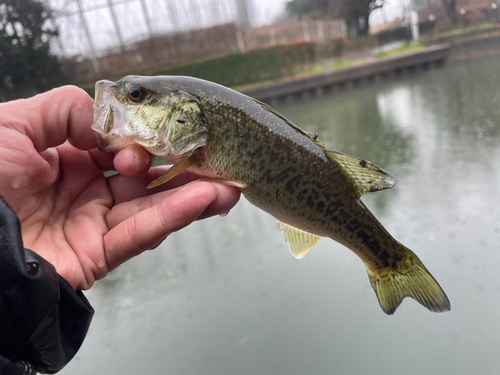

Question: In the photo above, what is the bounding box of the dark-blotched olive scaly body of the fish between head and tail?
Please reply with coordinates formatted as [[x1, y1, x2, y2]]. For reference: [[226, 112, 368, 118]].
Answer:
[[132, 77, 418, 267]]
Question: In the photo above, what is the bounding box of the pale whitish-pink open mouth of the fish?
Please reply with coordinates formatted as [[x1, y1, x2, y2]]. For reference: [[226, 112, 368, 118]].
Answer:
[[92, 80, 134, 152]]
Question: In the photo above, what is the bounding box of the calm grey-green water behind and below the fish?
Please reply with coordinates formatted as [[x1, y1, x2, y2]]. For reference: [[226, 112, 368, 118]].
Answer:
[[61, 57, 500, 375]]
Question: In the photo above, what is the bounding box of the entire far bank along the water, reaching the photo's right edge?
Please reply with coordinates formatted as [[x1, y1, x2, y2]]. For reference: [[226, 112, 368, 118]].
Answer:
[[239, 30, 500, 104]]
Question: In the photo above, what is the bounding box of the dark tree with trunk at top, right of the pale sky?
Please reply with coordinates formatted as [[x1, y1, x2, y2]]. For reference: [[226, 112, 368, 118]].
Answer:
[[333, 0, 384, 35]]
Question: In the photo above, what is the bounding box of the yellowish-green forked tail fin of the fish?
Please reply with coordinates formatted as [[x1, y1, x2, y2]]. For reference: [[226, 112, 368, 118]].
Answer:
[[367, 247, 451, 315]]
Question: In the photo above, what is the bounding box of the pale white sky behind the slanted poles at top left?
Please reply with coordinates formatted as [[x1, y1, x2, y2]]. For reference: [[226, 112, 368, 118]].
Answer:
[[46, 0, 287, 56]]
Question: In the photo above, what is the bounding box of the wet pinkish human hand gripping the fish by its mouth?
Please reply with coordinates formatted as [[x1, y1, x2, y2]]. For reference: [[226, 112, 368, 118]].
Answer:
[[0, 86, 240, 289]]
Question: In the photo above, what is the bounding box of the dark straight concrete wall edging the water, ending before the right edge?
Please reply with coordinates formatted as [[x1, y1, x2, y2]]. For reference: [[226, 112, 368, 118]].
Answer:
[[242, 45, 450, 103]]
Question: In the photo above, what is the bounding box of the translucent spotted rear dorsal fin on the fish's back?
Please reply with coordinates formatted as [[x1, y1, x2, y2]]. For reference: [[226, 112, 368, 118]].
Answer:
[[324, 149, 396, 196]]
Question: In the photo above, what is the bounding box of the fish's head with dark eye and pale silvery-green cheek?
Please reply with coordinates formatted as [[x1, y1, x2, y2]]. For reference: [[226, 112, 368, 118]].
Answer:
[[92, 76, 207, 162]]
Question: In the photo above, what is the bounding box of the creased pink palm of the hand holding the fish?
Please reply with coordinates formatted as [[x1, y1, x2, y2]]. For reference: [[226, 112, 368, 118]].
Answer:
[[4, 137, 113, 288]]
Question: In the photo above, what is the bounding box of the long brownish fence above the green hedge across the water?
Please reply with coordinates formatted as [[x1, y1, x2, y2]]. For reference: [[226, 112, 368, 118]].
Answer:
[[68, 20, 347, 81]]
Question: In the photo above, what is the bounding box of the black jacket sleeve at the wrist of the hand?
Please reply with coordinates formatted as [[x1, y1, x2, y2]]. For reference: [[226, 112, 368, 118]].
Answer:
[[0, 197, 94, 375]]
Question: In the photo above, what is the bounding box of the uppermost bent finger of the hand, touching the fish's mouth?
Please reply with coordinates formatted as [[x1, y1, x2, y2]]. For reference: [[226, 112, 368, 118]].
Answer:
[[0, 86, 97, 152]]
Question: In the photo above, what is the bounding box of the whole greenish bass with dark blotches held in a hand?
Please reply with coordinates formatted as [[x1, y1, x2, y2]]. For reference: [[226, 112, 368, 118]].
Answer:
[[92, 76, 451, 314]]
